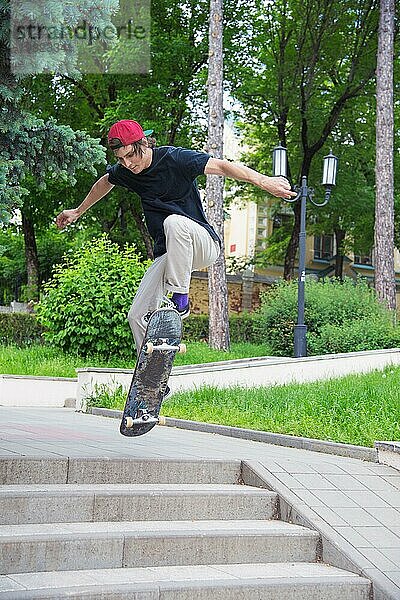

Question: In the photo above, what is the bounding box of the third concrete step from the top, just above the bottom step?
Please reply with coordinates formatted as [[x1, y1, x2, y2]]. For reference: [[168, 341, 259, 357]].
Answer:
[[0, 520, 320, 575]]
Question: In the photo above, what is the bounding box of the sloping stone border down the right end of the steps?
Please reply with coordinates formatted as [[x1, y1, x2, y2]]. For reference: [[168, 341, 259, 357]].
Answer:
[[242, 460, 399, 600]]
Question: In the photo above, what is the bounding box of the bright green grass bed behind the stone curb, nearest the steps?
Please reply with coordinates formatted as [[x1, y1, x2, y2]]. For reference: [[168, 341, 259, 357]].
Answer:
[[88, 367, 400, 446]]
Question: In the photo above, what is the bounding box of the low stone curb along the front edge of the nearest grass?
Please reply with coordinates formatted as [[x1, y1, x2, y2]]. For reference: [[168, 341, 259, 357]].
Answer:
[[91, 408, 378, 462]]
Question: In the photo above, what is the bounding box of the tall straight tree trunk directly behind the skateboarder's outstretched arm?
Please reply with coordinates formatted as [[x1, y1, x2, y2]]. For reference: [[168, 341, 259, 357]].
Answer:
[[206, 0, 230, 350]]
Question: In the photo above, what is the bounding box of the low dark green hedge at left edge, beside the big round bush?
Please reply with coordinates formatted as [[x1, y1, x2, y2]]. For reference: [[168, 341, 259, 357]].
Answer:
[[0, 313, 43, 346]]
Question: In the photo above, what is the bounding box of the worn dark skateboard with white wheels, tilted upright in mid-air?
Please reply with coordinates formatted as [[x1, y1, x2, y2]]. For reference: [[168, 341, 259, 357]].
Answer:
[[120, 308, 186, 437]]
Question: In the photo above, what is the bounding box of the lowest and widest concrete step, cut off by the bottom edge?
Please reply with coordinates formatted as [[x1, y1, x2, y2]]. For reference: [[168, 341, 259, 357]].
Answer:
[[0, 562, 371, 600]]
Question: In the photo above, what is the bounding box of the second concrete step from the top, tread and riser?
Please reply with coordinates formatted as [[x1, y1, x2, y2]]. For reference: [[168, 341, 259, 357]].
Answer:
[[0, 483, 278, 525]]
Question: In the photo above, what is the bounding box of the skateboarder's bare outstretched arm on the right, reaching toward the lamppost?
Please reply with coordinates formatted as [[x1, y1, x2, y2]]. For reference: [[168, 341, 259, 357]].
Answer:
[[204, 158, 297, 199]]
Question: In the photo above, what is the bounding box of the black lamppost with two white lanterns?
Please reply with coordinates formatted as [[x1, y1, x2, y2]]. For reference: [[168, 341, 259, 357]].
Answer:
[[272, 145, 338, 358]]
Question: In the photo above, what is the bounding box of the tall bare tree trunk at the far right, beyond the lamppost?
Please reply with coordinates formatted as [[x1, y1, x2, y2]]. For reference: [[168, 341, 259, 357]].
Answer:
[[375, 0, 396, 311]]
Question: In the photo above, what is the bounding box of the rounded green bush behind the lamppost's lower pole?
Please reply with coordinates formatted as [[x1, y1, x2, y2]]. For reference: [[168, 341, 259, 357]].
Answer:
[[254, 278, 396, 356]]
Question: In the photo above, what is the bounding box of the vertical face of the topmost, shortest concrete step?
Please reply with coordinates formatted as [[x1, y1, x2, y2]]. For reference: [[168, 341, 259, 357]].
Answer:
[[0, 456, 241, 485]]
